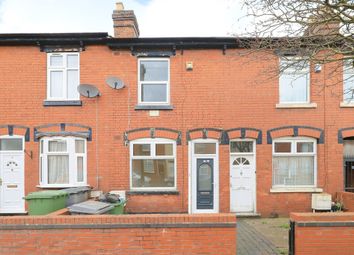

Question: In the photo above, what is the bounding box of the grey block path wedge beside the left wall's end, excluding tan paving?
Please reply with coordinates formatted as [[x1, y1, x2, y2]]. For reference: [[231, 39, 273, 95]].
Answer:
[[237, 218, 280, 255]]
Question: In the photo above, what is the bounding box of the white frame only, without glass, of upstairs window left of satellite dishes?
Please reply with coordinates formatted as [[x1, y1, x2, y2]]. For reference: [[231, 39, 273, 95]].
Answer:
[[46, 52, 80, 101]]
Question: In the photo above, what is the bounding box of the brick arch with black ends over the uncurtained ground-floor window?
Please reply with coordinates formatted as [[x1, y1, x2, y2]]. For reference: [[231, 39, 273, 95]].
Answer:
[[124, 127, 182, 145]]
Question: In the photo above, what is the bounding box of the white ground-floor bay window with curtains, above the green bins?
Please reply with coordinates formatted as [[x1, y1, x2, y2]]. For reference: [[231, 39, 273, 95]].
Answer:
[[39, 137, 87, 187]]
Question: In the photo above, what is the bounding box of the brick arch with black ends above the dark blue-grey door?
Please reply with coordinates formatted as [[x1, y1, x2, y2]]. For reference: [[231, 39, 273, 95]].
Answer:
[[186, 128, 224, 144]]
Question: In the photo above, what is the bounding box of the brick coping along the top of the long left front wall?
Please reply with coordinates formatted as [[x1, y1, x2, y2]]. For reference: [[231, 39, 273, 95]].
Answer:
[[0, 214, 236, 230]]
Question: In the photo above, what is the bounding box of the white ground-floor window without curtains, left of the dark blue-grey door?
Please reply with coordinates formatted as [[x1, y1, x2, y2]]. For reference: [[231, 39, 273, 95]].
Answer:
[[130, 138, 176, 191]]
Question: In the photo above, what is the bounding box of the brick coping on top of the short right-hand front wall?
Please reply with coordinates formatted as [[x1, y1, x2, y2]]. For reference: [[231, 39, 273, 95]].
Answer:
[[290, 212, 354, 222]]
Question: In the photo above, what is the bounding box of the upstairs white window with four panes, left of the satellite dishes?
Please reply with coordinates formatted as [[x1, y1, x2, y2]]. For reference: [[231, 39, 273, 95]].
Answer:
[[47, 52, 80, 101]]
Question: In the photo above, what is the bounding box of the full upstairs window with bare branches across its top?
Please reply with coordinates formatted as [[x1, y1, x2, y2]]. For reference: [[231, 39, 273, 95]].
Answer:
[[279, 57, 310, 104]]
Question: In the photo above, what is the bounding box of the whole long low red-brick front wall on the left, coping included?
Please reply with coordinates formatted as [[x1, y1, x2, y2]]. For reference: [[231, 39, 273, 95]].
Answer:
[[0, 214, 236, 255]]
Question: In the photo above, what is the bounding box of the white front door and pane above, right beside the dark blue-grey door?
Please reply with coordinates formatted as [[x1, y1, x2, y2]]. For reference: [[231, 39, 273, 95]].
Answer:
[[230, 140, 256, 213]]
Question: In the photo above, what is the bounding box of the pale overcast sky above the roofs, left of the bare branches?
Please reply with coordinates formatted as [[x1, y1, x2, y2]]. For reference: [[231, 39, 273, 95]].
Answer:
[[0, 0, 245, 37]]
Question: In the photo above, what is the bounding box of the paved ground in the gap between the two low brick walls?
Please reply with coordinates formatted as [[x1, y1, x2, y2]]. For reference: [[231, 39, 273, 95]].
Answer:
[[237, 218, 289, 255]]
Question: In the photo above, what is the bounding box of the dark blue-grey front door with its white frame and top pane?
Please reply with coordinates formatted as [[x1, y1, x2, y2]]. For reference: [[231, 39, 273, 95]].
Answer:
[[189, 139, 219, 213]]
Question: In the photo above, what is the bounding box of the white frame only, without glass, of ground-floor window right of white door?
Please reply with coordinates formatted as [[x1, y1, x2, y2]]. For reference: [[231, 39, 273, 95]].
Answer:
[[272, 137, 317, 189]]
